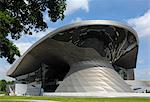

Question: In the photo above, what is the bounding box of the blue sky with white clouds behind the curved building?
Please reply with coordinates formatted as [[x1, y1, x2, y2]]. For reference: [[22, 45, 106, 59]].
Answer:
[[0, 0, 150, 81]]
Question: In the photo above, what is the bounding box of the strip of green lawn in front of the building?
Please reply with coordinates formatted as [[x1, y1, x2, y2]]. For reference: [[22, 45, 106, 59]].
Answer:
[[0, 96, 150, 102]]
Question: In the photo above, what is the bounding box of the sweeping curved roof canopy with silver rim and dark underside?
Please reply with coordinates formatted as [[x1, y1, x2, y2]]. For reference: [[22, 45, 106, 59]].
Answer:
[[7, 20, 138, 77]]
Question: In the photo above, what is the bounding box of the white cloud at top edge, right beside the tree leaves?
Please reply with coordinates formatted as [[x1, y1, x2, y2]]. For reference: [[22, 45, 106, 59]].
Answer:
[[65, 0, 89, 14]]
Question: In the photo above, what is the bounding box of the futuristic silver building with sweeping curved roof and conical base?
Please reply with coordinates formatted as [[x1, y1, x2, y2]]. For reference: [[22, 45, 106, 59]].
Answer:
[[7, 20, 138, 95]]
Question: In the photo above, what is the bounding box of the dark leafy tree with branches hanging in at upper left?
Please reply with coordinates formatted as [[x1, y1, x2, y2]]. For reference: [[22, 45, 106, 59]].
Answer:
[[0, 0, 66, 64]]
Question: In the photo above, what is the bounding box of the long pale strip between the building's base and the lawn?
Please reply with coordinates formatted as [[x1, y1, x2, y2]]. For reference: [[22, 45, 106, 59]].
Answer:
[[43, 92, 150, 98]]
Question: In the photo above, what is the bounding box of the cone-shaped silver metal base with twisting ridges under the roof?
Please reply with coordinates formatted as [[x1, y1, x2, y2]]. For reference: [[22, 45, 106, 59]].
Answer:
[[55, 61, 132, 92]]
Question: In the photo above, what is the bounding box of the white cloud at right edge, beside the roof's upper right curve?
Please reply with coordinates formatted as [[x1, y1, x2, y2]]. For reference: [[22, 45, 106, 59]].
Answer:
[[127, 10, 150, 37]]
